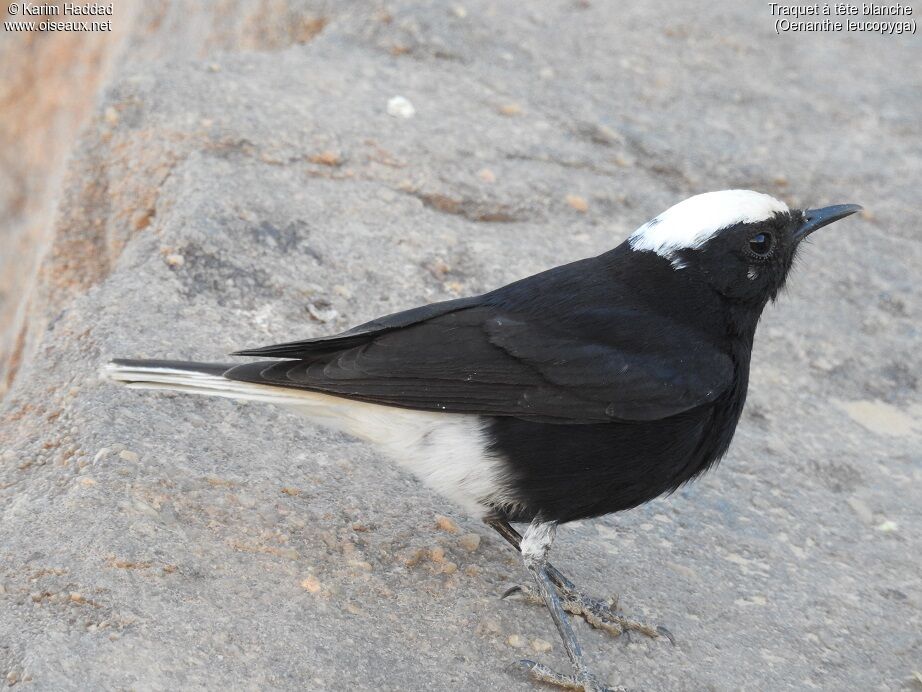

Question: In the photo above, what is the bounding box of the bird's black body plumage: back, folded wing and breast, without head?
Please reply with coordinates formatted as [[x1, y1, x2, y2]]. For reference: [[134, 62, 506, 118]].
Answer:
[[225, 230, 755, 522]]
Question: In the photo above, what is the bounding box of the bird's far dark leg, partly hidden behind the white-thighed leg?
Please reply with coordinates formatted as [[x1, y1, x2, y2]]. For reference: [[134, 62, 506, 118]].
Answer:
[[484, 516, 675, 644]]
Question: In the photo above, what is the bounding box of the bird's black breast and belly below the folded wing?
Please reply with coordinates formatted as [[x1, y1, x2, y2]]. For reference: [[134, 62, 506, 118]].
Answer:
[[485, 386, 745, 522]]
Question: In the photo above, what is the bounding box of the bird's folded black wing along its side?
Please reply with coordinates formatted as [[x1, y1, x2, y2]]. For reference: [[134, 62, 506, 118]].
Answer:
[[225, 299, 733, 423]]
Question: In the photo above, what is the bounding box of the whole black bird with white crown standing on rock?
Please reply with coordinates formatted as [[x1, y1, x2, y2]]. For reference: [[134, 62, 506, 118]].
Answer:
[[106, 190, 862, 692]]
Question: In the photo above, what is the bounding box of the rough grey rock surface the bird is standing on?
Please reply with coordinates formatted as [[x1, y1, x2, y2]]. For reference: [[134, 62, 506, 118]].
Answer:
[[0, 0, 922, 690]]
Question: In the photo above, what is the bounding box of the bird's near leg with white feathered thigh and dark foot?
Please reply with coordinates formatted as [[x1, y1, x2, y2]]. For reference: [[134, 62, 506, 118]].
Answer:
[[519, 519, 608, 692]]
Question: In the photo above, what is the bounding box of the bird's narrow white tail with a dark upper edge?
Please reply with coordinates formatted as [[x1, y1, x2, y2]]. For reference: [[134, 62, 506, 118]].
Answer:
[[103, 359, 309, 405]]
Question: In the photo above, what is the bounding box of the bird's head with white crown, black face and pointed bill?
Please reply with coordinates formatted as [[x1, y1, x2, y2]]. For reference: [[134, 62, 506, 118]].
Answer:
[[628, 190, 861, 306]]
